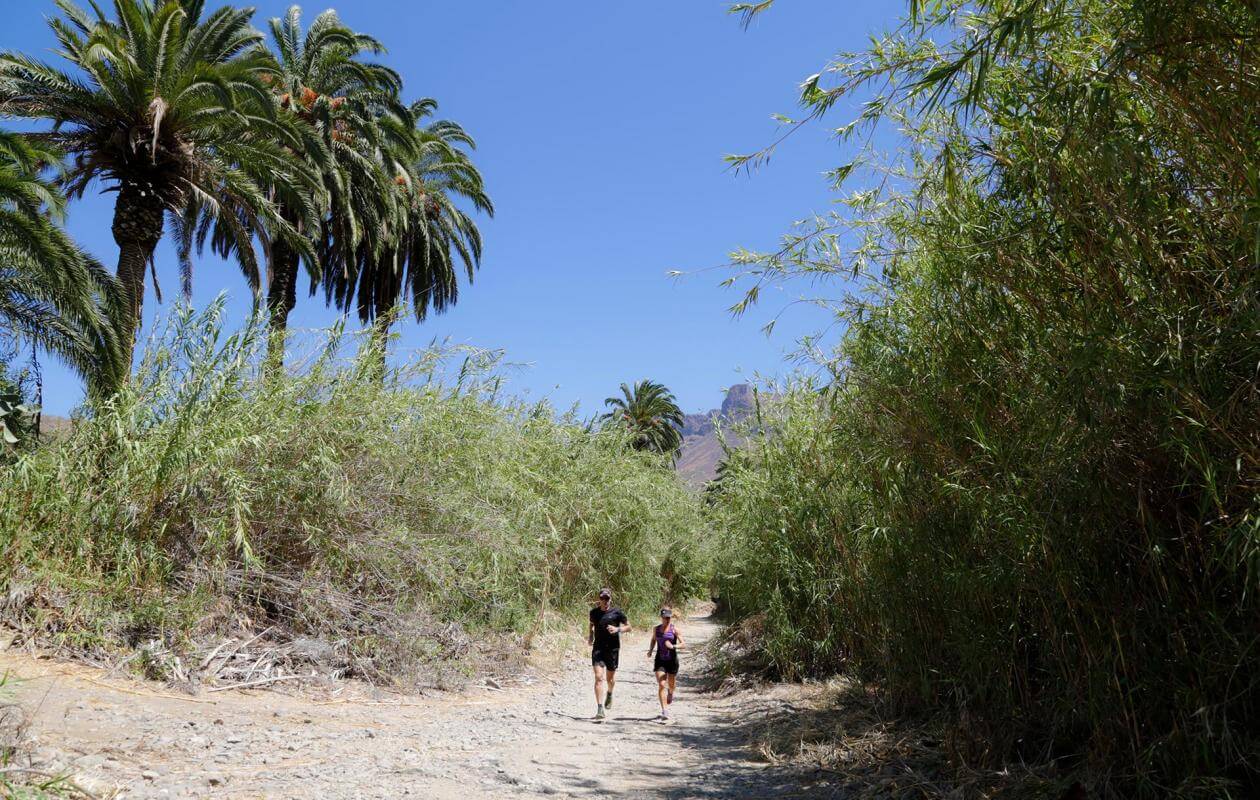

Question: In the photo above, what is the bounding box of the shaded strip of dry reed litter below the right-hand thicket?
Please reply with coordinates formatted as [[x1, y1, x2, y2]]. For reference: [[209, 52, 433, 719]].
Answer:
[[659, 674, 1076, 800]]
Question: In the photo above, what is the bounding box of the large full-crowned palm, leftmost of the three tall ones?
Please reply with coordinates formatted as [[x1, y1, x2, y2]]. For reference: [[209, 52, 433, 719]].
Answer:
[[0, 0, 319, 355]]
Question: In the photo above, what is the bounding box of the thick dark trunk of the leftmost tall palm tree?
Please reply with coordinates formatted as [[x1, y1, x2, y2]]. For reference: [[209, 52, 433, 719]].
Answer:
[[112, 183, 165, 363]]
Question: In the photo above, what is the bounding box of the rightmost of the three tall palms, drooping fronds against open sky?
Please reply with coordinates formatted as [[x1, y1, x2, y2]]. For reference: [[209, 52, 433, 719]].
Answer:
[[324, 98, 494, 372]]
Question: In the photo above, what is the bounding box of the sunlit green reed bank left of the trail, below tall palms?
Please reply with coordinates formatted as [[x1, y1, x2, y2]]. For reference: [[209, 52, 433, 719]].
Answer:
[[0, 306, 707, 677]]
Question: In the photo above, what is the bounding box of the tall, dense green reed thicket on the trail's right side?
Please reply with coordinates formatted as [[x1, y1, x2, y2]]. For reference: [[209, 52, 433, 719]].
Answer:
[[716, 0, 1260, 797]]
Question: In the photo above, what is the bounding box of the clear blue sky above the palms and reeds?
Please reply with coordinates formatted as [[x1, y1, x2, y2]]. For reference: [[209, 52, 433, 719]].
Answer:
[[7, 0, 905, 413]]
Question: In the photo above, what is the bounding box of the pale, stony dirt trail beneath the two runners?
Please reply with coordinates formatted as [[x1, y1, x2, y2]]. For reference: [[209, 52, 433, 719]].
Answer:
[[0, 619, 846, 800]]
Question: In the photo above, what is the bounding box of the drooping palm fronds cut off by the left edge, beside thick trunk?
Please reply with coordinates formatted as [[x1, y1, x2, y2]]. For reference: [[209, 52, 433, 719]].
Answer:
[[0, 132, 127, 396]]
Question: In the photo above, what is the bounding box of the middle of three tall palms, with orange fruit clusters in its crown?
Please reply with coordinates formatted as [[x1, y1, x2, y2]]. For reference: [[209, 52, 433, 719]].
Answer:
[[252, 5, 403, 365]]
